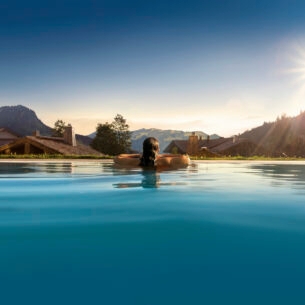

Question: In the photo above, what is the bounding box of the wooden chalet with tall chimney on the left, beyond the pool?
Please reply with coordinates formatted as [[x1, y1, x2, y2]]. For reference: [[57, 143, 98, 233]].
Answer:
[[0, 126, 102, 156]]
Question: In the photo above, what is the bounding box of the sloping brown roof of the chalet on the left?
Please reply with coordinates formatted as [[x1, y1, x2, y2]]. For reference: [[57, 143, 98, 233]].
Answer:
[[0, 136, 102, 155]]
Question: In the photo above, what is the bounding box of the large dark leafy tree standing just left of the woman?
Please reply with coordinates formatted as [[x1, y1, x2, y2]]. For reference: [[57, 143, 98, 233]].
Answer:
[[91, 114, 131, 155]]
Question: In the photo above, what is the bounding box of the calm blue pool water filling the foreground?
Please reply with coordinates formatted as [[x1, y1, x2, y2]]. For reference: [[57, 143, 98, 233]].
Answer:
[[0, 161, 305, 305]]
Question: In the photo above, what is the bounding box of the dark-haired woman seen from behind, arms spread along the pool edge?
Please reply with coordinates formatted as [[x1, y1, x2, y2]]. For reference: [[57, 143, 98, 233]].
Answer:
[[114, 137, 190, 168]]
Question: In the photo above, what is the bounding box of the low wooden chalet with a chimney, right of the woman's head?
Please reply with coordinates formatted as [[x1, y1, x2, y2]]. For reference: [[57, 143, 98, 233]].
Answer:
[[164, 133, 263, 157]]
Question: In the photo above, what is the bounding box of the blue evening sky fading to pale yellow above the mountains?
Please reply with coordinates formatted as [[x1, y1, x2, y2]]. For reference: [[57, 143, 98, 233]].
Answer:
[[0, 0, 305, 136]]
